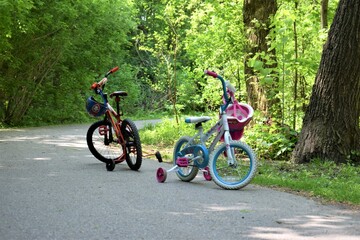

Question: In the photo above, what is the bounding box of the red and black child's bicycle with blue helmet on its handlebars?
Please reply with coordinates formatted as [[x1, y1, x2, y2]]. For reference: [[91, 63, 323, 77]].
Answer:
[[86, 67, 142, 171]]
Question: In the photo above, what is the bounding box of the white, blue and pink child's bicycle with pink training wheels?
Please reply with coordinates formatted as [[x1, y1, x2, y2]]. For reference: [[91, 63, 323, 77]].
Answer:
[[156, 71, 257, 189]]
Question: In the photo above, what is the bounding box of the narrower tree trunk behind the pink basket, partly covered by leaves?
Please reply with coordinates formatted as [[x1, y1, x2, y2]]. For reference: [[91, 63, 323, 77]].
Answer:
[[243, 0, 277, 116]]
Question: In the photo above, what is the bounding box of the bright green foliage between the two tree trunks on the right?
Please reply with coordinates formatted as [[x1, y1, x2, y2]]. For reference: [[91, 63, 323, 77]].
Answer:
[[265, 1, 338, 130]]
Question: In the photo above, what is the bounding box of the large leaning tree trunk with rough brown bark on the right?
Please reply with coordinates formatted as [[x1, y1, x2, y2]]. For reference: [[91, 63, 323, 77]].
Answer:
[[293, 0, 360, 163]]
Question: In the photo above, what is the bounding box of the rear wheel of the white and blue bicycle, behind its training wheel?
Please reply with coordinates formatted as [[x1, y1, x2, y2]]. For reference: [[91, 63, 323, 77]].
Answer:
[[173, 136, 199, 182]]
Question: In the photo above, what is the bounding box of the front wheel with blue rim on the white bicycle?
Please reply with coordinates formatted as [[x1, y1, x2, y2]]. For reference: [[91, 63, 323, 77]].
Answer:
[[209, 141, 257, 189]]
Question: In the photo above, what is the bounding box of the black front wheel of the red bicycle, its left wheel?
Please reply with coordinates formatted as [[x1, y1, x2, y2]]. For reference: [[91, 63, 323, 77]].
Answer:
[[86, 120, 123, 163]]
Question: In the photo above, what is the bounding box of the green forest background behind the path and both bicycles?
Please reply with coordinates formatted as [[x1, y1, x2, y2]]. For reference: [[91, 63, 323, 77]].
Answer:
[[0, 0, 360, 206]]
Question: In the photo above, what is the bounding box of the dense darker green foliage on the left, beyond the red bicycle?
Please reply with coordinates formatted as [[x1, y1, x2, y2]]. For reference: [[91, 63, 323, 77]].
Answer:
[[0, 0, 137, 124]]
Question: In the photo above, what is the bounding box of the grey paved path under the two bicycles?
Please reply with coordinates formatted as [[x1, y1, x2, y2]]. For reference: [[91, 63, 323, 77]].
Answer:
[[0, 125, 360, 240]]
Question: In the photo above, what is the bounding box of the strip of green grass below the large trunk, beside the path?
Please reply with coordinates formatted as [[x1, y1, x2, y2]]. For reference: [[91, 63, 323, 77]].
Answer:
[[253, 160, 360, 207]]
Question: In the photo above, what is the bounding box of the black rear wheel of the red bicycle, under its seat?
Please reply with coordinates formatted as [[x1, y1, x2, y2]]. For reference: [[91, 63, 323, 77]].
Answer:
[[121, 119, 142, 171]]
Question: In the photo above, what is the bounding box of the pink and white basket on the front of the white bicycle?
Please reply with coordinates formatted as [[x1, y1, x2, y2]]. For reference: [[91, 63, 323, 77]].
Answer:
[[221, 100, 254, 141]]
